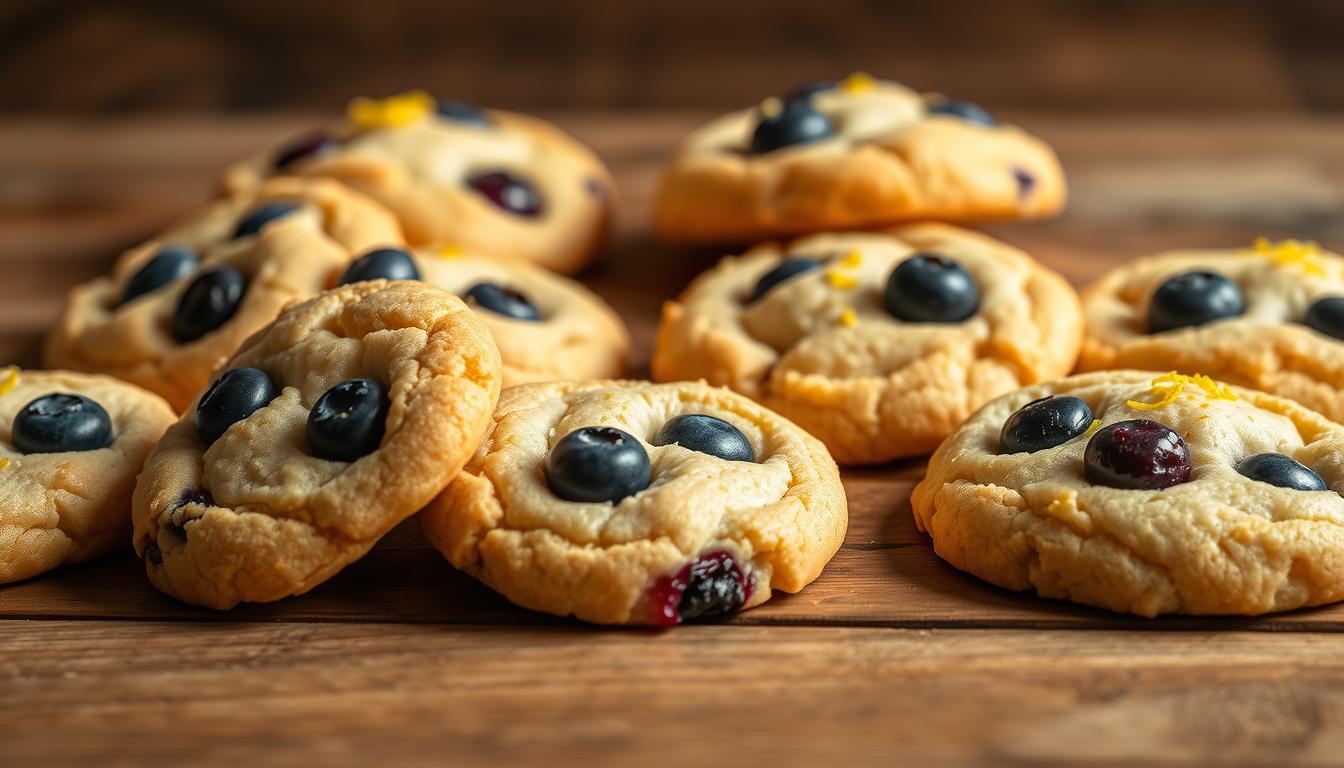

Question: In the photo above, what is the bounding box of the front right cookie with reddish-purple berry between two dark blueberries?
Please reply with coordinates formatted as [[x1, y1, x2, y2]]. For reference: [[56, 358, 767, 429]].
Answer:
[[911, 371, 1344, 616]]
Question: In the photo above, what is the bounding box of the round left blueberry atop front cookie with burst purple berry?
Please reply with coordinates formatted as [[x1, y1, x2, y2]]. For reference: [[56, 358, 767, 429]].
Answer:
[[546, 426, 652, 503]]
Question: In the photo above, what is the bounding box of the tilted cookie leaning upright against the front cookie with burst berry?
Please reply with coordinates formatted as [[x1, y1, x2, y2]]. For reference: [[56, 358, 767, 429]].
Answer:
[[133, 281, 500, 609]]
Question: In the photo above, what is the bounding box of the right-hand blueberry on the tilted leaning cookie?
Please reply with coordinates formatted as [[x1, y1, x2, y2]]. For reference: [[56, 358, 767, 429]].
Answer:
[[308, 379, 390, 461]]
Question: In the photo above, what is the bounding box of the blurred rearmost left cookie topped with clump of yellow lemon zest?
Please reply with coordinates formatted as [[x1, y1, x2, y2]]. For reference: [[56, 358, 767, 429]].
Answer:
[[224, 91, 613, 273]]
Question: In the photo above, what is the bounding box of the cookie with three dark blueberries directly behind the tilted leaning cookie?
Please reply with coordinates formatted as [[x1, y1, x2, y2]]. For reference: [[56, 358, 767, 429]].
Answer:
[[44, 179, 402, 410]]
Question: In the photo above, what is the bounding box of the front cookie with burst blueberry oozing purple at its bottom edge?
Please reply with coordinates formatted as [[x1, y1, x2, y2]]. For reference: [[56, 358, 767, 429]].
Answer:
[[421, 381, 848, 625]]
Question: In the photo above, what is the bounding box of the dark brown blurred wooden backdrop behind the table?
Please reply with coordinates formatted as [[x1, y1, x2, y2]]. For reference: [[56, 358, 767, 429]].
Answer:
[[0, 0, 1344, 113]]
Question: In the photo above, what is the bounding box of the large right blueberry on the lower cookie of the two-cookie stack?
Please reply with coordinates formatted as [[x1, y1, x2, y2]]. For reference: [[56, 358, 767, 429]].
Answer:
[[883, 253, 980, 323]]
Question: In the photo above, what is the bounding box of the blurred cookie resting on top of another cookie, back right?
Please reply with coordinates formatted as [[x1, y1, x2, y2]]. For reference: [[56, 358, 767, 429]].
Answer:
[[657, 74, 1064, 242]]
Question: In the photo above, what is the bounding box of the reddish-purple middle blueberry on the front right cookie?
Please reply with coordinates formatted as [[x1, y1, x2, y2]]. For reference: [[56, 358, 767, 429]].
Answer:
[[1083, 418, 1193, 491]]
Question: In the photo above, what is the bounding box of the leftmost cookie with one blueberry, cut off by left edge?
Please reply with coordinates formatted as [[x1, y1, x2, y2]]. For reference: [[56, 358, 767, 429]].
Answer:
[[0, 366, 175, 584]]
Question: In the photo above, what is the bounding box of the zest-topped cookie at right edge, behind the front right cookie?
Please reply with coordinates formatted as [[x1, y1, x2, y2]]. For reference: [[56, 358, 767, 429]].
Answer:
[[1078, 238, 1344, 421]]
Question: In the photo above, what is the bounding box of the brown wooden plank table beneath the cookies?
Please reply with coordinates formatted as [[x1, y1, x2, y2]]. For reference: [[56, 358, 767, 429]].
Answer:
[[0, 113, 1344, 765]]
